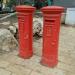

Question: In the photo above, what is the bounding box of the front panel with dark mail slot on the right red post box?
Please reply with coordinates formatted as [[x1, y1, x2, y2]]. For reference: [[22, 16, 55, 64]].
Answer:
[[43, 18, 56, 57]]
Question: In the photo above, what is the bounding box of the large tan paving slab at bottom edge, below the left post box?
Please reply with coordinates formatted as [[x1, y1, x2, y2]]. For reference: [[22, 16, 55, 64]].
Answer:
[[6, 65, 32, 75]]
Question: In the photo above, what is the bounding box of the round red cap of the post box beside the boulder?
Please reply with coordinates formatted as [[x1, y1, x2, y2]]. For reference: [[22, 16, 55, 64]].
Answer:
[[16, 5, 35, 12]]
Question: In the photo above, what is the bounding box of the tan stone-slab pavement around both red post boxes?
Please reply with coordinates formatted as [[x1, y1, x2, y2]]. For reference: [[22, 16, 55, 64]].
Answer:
[[0, 26, 75, 75]]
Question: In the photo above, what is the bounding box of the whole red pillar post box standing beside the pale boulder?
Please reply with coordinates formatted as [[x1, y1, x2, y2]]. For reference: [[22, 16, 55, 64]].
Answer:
[[16, 5, 35, 58]]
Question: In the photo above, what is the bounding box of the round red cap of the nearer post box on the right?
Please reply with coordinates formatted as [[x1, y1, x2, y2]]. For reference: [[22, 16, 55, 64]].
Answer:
[[41, 6, 64, 12]]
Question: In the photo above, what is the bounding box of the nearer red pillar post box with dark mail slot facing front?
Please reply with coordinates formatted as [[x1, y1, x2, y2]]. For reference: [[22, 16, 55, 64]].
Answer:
[[41, 6, 64, 67]]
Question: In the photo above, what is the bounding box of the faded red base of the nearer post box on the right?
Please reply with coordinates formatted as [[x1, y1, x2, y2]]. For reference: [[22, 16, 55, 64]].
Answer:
[[40, 59, 58, 67]]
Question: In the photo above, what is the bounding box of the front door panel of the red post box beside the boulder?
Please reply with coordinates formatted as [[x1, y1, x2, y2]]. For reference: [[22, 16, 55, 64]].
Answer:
[[19, 15, 29, 50]]
